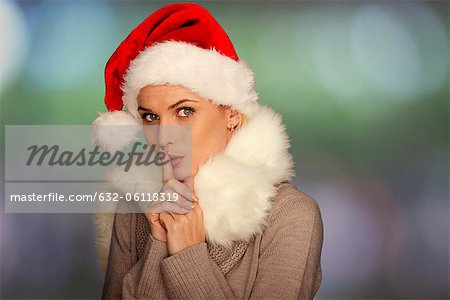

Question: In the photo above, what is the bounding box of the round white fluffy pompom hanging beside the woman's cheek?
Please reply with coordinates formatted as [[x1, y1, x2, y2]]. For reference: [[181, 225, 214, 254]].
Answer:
[[90, 110, 142, 153]]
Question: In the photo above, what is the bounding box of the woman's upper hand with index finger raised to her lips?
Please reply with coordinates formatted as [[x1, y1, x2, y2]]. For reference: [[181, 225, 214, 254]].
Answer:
[[145, 149, 194, 243]]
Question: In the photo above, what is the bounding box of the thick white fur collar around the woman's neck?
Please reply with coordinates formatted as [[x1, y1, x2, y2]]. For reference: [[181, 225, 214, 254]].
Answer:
[[96, 105, 294, 267]]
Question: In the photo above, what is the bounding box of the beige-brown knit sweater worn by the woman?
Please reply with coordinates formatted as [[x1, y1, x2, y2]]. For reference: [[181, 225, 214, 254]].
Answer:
[[102, 182, 323, 299]]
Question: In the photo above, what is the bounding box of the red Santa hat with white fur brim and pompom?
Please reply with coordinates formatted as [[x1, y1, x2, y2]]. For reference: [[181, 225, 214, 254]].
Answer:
[[91, 3, 258, 151]]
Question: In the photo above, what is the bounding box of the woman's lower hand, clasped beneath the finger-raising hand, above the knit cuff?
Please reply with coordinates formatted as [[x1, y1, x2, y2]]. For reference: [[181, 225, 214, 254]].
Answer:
[[159, 197, 205, 255]]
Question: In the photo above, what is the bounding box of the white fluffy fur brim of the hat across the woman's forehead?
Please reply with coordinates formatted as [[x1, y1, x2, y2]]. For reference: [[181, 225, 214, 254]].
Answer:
[[122, 41, 258, 116]]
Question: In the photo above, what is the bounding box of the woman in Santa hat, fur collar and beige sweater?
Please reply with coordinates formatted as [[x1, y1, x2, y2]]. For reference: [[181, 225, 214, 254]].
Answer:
[[92, 3, 323, 299]]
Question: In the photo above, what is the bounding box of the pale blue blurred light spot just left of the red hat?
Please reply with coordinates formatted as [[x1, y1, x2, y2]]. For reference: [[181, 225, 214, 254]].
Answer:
[[27, 1, 116, 90]]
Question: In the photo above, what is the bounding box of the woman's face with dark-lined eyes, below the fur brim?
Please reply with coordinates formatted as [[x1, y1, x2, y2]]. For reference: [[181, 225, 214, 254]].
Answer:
[[138, 85, 241, 180]]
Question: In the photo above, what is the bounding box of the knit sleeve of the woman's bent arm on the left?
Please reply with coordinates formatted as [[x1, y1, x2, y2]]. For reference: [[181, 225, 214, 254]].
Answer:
[[102, 200, 167, 299]]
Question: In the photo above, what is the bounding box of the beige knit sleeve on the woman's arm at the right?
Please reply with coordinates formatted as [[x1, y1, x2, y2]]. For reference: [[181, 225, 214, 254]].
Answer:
[[250, 191, 323, 299]]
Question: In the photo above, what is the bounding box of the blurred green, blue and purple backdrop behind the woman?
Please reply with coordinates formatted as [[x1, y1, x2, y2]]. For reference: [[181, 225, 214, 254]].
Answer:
[[0, 0, 449, 299]]
